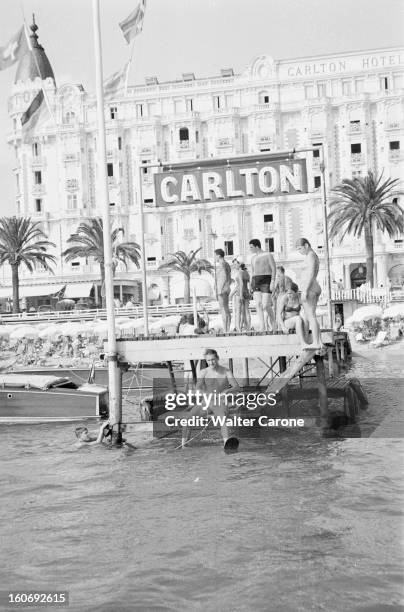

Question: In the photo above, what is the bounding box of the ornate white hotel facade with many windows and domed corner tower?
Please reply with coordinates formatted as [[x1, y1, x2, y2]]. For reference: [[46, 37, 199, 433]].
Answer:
[[1, 26, 404, 308]]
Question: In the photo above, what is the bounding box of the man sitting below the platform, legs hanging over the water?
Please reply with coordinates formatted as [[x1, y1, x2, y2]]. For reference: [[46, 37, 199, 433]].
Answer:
[[182, 349, 240, 447]]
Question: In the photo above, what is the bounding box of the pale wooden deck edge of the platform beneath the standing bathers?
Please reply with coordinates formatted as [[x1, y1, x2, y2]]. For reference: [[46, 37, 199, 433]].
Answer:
[[112, 330, 334, 362]]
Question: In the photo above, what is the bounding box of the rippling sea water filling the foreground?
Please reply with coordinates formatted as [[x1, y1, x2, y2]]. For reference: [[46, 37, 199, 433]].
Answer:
[[0, 349, 404, 612]]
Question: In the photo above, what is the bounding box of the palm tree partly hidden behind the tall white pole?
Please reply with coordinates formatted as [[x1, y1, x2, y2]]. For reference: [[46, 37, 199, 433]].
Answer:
[[62, 217, 140, 307]]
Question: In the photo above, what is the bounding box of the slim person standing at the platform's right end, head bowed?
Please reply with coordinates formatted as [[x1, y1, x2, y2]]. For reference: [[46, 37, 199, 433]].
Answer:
[[296, 238, 323, 349]]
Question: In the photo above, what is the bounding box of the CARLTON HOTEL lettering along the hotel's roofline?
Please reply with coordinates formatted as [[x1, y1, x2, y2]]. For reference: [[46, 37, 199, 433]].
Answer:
[[288, 53, 404, 77]]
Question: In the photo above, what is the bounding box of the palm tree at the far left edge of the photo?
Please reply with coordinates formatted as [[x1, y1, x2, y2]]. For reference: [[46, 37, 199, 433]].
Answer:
[[0, 217, 56, 312]]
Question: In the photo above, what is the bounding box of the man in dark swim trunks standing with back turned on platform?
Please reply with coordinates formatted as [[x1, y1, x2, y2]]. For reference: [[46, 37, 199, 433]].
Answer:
[[249, 238, 276, 331]]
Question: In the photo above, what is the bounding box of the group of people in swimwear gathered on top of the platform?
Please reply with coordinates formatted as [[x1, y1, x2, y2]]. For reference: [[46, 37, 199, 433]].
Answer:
[[215, 238, 321, 349]]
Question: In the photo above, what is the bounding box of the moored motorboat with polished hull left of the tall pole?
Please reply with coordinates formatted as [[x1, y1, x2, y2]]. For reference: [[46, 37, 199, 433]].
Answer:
[[0, 374, 108, 423]]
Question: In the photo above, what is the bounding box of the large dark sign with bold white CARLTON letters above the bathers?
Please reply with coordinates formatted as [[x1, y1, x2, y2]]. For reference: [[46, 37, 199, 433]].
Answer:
[[154, 159, 307, 206]]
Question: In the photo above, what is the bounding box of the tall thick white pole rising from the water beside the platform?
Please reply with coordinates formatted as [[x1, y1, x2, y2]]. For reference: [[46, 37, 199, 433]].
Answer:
[[93, 0, 122, 436]]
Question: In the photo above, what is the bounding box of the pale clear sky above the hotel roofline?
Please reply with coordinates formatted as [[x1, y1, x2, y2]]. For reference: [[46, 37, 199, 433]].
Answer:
[[0, 0, 404, 215]]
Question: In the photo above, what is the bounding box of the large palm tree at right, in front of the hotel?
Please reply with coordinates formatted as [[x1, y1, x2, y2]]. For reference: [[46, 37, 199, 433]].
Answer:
[[328, 170, 404, 287]]
